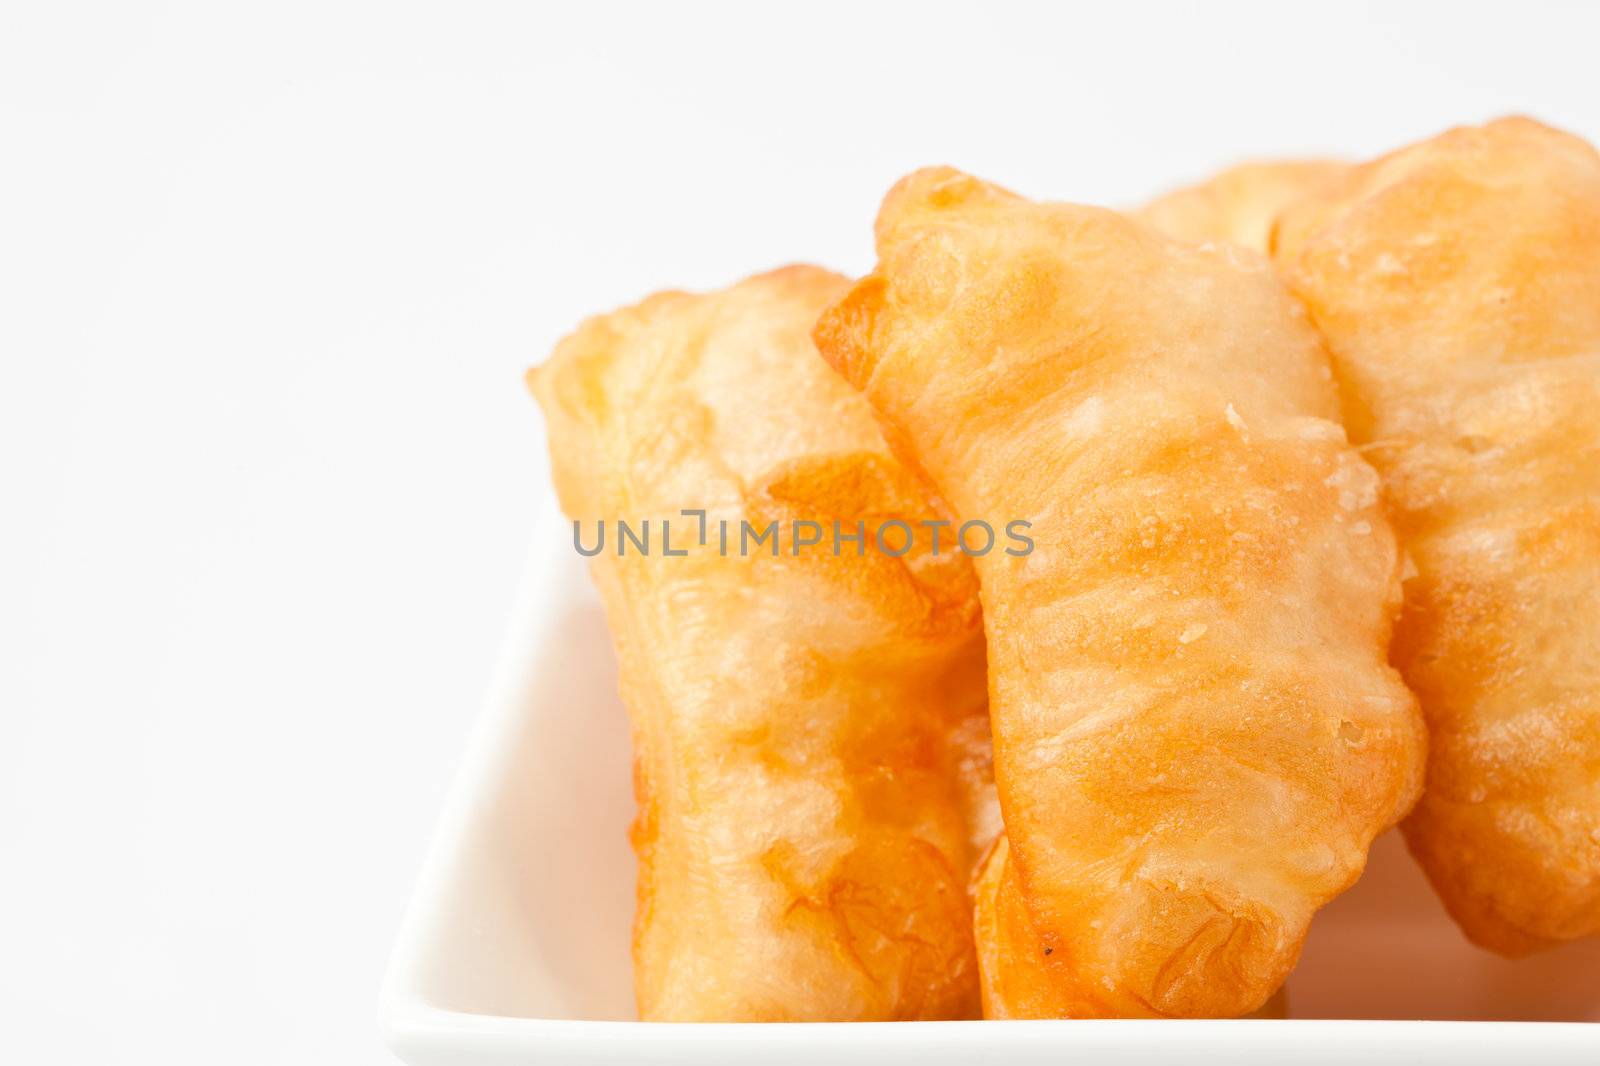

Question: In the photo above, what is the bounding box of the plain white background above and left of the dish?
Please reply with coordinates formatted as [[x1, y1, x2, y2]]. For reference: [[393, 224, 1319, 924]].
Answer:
[[0, 0, 1600, 1063]]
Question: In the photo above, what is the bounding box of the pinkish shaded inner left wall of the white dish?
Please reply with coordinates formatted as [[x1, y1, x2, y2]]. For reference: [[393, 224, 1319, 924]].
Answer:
[[412, 589, 635, 1021]]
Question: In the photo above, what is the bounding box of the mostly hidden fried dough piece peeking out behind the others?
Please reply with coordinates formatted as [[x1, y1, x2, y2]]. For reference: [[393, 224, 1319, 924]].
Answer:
[[1136, 160, 1350, 251]]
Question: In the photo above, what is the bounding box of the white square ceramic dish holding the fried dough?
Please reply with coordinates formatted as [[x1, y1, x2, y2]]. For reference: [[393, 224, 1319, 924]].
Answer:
[[382, 503, 1600, 1066]]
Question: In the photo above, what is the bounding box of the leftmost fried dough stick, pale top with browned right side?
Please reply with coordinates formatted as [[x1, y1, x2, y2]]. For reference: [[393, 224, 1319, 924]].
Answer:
[[531, 267, 987, 1021]]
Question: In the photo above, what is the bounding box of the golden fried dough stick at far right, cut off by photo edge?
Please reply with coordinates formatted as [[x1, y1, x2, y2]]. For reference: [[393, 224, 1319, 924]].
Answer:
[[1278, 118, 1600, 954]]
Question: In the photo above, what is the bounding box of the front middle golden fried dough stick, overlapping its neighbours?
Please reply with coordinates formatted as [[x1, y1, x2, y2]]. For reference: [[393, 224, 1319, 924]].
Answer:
[[816, 170, 1424, 1016]]
